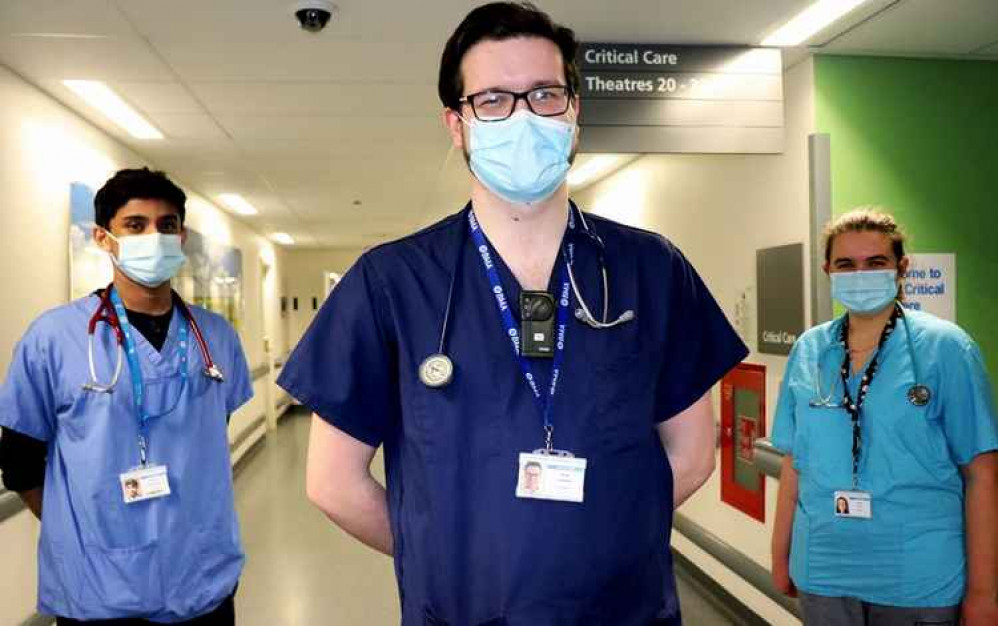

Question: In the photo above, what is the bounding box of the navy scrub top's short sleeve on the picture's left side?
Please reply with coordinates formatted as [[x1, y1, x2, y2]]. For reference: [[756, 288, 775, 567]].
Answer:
[[277, 255, 401, 446]]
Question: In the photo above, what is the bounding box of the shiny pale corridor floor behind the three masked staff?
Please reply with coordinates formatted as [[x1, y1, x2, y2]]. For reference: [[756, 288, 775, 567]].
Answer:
[[230, 413, 738, 626]]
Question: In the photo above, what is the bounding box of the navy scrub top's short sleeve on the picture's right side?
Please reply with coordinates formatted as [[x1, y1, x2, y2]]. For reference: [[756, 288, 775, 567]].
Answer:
[[657, 243, 748, 420]]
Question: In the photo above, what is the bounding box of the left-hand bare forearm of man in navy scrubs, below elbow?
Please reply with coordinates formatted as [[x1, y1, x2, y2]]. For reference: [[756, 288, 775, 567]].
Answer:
[[309, 476, 394, 556]]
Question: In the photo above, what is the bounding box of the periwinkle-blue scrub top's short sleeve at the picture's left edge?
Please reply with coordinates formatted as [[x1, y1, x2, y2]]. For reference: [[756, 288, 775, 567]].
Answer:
[[0, 322, 56, 441]]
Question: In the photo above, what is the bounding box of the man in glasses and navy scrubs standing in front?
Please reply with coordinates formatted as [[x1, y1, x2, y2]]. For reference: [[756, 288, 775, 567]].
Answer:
[[279, 3, 747, 626]]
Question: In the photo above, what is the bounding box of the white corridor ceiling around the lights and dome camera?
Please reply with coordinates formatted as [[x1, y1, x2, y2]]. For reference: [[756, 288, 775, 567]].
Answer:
[[0, 0, 998, 247]]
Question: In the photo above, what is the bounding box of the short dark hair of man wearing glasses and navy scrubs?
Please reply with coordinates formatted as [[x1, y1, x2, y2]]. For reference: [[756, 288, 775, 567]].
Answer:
[[437, 2, 582, 110]]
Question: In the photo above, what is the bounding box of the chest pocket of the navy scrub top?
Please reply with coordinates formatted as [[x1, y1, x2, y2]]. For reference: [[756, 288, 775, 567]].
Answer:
[[593, 351, 665, 452]]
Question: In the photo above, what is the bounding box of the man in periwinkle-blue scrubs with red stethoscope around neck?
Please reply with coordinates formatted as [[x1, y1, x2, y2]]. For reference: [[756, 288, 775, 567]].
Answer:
[[0, 169, 252, 626]]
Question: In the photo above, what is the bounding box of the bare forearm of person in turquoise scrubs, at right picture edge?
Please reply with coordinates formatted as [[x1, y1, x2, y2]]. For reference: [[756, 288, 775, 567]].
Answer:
[[965, 452, 998, 600]]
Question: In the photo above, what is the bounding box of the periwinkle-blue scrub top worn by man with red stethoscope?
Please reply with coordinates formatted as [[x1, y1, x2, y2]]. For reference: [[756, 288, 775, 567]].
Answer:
[[0, 295, 252, 623]]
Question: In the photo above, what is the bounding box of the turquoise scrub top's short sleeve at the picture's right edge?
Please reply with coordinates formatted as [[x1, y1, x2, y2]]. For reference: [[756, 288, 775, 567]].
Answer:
[[940, 341, 998, 465]]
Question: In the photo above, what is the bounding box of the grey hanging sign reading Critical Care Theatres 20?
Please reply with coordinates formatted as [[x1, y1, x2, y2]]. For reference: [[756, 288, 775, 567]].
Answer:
[[578, 43, 783, 153]]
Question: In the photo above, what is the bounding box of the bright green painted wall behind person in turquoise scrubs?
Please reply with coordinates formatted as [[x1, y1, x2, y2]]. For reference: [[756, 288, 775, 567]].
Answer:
[[815, 56, 998, 391]]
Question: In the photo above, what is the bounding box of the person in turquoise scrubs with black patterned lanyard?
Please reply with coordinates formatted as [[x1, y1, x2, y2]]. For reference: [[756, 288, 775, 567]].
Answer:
[[773, 209, 998, 626]]
